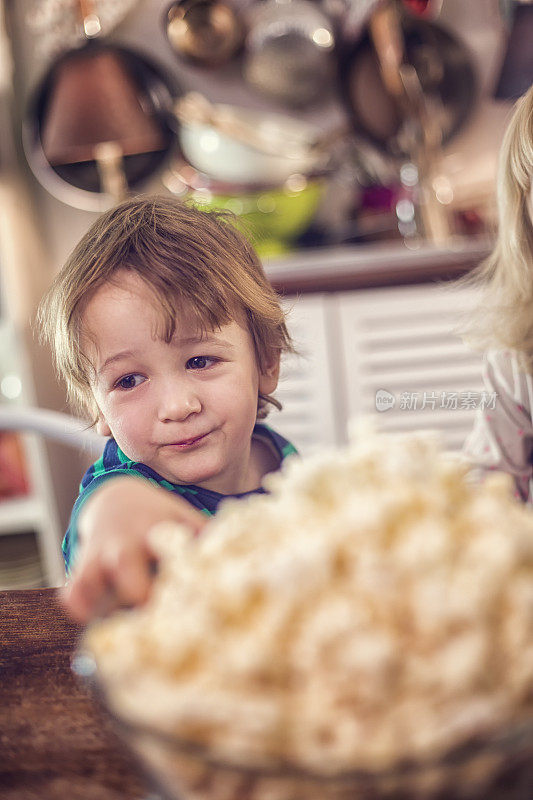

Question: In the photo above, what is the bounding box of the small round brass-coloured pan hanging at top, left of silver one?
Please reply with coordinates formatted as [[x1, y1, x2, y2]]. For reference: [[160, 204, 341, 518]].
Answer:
[[166, 0, 244, 66]]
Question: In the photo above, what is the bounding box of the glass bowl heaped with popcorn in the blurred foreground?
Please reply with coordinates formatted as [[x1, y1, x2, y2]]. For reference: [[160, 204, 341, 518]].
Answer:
[[78, 430, 533, 800]]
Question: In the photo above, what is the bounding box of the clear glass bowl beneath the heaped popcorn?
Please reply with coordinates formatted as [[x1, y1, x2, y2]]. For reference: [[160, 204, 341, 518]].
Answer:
[[72, 651, 533, 800]]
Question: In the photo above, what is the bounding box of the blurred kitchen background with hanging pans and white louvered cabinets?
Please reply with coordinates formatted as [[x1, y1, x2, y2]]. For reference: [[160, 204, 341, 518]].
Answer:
[[0, 0, 533, 588]]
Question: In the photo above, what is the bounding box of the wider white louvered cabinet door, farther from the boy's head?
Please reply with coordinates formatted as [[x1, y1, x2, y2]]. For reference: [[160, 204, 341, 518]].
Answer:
[[337, 284, 484, 450]]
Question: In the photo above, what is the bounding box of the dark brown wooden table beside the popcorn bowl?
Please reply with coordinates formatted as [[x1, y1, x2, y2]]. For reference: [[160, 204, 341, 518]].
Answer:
[[0, 589, 150, 800]]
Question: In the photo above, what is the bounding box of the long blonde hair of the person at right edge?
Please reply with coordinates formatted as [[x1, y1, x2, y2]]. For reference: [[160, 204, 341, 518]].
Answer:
[[460, 86, 533, 372]]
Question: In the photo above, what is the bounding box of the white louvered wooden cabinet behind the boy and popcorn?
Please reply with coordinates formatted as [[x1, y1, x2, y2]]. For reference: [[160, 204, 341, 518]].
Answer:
[[269, 283, 484, 453]]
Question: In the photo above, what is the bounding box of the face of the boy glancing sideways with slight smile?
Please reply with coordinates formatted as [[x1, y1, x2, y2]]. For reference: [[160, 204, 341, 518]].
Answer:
[[82, 270, 279, 494]]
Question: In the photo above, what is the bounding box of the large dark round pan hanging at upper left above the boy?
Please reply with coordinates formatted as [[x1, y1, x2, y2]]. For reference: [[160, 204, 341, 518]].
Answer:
[[23, 0, 176, 211]]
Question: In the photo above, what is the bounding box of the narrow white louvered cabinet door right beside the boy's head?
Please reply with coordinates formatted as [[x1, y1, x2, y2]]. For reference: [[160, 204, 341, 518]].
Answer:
[[266, 294, 337, 454]]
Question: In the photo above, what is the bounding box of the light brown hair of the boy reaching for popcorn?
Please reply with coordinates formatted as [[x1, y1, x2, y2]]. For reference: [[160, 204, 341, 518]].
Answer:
[[38, 195, 294, 425]]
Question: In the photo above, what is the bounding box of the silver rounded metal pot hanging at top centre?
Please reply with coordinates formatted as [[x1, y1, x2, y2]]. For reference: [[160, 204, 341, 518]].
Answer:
[[243, 0, 335, 108]]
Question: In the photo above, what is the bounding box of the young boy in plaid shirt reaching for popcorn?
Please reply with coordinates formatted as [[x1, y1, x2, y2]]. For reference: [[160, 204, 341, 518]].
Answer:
[[39, 196, 295, 622]]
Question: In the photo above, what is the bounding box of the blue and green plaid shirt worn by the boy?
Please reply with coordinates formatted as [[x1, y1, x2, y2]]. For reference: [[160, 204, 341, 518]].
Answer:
[[63, 423, 296, 575]]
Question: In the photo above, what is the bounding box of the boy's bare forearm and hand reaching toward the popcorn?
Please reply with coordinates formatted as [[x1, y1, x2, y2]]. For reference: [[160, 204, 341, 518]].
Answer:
[[60, 476, 208, 623]]
